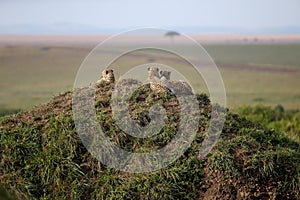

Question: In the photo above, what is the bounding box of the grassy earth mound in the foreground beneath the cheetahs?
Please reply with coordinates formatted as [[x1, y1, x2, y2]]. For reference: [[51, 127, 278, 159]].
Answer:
[[0, 81, 300, 199]]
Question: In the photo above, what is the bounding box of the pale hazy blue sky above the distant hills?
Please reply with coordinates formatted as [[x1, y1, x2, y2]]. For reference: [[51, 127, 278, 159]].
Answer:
[[0, 0, 300, 32]]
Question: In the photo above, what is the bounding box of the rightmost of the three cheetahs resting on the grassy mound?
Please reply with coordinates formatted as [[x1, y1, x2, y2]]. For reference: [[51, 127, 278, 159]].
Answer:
[[159, 70, 193, 95]]
